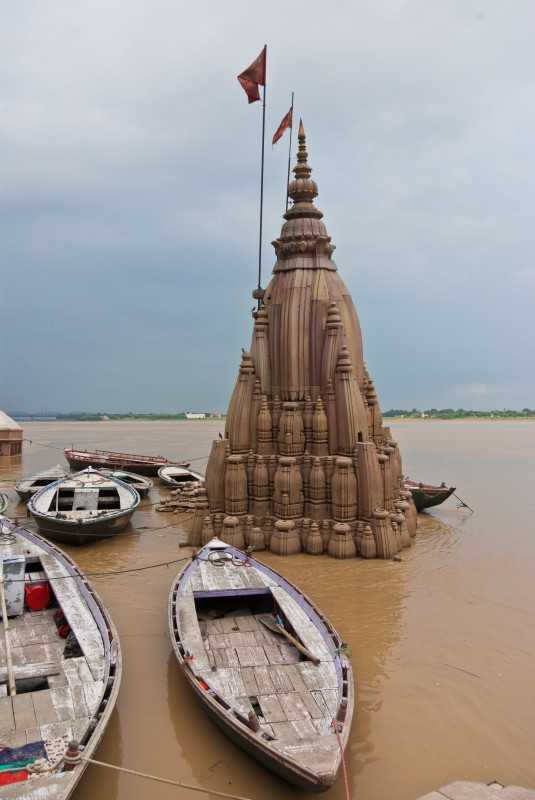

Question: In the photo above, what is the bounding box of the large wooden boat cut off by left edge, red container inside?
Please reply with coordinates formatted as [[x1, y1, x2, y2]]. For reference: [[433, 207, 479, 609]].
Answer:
[[0, 518, 122, 800]]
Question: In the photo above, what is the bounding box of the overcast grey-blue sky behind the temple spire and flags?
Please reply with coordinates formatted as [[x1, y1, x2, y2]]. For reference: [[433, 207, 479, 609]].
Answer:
[[0, 0, 535, 411]]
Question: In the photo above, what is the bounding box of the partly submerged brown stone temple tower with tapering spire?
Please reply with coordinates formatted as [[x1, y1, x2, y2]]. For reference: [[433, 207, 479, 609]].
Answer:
[[197, 124, 416, 558]]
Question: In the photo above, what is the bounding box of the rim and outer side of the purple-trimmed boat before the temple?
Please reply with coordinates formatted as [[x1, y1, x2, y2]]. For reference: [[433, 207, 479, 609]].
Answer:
[[168, 543, 356, 791]]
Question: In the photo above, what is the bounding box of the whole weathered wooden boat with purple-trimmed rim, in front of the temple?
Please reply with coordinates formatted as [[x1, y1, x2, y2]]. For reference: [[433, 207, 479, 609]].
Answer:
[[169, 539, 354, 791]]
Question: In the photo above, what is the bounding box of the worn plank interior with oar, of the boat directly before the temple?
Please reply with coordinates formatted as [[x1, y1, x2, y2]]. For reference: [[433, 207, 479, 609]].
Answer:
[[175, 552, 349, 773]]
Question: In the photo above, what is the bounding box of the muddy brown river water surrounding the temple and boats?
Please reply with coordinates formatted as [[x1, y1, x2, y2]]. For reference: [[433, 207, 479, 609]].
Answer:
[[0, 421, 535, 800]]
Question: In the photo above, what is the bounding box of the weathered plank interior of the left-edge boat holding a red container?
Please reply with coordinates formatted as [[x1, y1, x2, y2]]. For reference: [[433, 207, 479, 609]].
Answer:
[[0, 535, 105, 786]]
